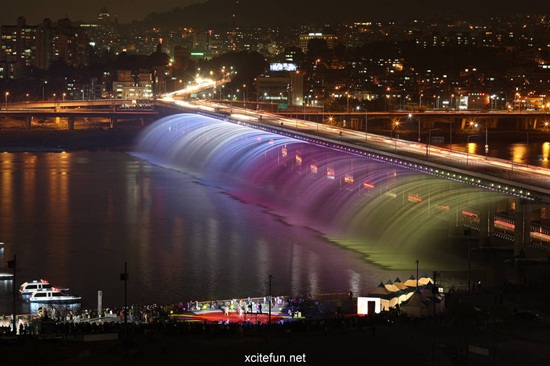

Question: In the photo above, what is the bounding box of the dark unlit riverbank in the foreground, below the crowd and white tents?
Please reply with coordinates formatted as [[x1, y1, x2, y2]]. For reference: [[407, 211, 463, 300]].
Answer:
[[0, 286, 550, 365]]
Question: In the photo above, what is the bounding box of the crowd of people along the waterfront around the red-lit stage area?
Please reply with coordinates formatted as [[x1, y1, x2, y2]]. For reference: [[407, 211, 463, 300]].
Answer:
[[0, 295, 394, 337]]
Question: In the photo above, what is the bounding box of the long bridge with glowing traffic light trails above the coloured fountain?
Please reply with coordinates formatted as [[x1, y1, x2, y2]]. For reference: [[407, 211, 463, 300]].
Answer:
[[153, 96, 550, 257]]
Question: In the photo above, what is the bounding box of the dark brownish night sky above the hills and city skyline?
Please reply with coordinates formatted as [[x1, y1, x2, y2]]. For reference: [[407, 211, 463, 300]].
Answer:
[[0, 0, 550, 24]]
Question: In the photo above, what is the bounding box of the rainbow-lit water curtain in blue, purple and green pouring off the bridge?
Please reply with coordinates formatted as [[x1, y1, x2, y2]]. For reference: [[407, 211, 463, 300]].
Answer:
[[135, 114, 508, 269]]
